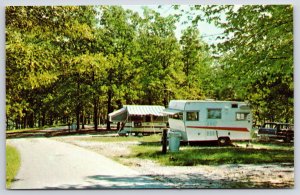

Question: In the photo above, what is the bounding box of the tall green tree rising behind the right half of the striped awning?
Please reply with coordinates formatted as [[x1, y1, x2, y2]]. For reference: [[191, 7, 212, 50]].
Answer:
[[137, 9, 184, 106]]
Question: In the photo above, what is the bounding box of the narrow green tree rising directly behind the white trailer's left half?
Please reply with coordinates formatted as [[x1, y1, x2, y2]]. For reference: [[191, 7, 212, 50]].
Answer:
[[180, 26, 212, 99]]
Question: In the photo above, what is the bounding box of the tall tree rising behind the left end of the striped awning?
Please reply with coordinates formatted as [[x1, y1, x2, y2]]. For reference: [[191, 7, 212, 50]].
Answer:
[[100, 6, 139, 130]]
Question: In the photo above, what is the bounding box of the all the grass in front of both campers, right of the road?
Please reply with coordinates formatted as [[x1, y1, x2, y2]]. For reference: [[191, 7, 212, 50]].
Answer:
[[81, 135, 294, 166]]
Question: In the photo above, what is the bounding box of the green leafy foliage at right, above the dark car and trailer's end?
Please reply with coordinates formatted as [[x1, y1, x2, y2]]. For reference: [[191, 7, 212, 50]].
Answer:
[[202, 5, 294, 122]]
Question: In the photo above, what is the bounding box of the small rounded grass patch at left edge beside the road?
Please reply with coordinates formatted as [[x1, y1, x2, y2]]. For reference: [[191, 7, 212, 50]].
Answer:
[[6, 145, 21, 189]]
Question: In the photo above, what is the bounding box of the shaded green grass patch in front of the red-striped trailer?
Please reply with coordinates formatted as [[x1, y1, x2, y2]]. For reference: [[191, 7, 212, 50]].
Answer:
[[131, 145, 294, 166]]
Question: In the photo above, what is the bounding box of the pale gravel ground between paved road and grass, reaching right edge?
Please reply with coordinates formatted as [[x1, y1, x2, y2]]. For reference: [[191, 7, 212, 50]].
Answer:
[[53, 137, 294, 188]]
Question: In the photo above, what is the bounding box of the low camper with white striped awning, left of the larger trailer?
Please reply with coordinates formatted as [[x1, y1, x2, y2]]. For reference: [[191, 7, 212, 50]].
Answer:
[[109, 105, 168, 135]]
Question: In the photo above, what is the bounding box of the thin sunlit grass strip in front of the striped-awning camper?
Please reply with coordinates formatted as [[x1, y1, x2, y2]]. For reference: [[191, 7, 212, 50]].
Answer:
[[81, 134, 161, 142]]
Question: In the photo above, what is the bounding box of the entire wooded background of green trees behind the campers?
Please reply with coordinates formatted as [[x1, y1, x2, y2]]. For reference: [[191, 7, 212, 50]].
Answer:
[[6, 5, 294, 129]]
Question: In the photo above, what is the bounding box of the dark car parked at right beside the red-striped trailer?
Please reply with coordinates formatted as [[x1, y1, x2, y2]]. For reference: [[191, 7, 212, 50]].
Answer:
[[257, 122, 294, 142]]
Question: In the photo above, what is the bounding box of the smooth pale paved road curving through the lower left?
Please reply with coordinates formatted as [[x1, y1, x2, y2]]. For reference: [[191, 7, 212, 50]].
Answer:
[[7, 138, 168, 189]]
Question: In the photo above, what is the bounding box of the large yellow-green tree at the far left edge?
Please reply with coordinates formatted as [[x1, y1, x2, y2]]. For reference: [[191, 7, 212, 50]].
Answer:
[[6, 6, 58, 128]]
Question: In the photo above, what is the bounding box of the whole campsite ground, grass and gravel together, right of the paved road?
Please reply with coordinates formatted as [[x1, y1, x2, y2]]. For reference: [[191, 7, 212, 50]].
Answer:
[[8, 121, 294, 189]]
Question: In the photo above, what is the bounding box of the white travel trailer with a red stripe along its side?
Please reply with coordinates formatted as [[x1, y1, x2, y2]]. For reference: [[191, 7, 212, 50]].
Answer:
[[163, 100, 252, 145]]
